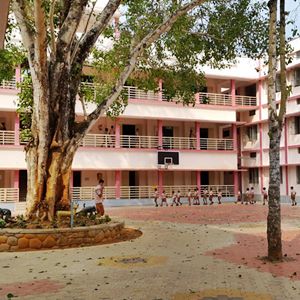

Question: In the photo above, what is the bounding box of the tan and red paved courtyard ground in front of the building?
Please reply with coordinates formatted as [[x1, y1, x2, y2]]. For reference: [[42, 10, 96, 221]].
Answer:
[[0, 204, 300, 300]]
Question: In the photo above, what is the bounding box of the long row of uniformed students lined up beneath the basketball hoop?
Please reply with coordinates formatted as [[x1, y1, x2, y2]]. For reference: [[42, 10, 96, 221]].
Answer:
[[153, 188, 222, 207]]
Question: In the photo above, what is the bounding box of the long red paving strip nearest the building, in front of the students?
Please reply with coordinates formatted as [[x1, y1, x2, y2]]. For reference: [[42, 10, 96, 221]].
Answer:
[[107, 204, 300, 224]]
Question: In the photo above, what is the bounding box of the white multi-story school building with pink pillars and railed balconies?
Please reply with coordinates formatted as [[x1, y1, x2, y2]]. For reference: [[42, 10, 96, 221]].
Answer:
[[0, 39, 300, 211]]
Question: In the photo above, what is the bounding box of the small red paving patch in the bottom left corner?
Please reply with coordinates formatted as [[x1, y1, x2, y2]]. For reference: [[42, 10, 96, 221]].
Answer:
[[0, 279, 64, 299]]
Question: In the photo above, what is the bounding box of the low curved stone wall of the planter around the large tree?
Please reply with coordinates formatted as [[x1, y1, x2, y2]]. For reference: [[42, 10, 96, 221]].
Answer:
[[0, 222, 124, 252]]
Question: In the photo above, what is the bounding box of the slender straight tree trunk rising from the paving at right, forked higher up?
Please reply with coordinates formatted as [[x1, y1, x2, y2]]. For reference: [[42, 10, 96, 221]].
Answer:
[[267, 0, 289, 261]]
